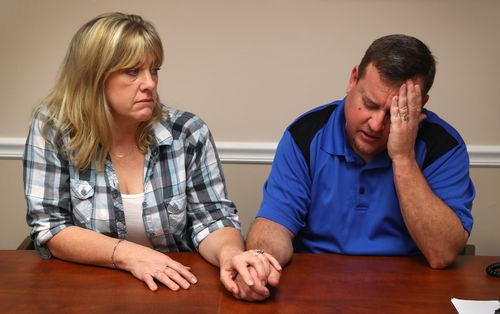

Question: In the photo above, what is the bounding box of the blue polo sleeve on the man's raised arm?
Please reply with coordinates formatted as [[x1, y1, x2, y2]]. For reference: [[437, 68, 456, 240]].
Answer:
[[423, 142, 475, 234]]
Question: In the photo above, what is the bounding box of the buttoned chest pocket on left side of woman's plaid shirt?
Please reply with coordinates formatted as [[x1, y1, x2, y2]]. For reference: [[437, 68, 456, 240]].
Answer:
[[70, 180, 94, 227]]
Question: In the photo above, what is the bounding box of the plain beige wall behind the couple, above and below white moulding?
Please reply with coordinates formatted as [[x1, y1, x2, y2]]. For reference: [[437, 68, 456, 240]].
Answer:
[[0, 0, 500, 255]]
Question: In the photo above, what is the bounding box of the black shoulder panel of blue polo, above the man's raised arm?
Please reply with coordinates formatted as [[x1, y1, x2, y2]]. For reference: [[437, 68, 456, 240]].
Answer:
[[418, 121, 458, 169]]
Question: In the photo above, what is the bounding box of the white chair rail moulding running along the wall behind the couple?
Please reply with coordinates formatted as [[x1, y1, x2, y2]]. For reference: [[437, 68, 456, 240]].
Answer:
[[0, 137, 500, 167]]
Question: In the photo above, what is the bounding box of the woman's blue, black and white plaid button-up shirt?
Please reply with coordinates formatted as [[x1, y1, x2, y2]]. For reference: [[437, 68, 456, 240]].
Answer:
[[24, 107, 241, 258]]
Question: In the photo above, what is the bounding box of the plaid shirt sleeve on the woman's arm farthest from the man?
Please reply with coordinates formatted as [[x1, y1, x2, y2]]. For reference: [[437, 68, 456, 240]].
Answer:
[[23, 112, 72, 258]]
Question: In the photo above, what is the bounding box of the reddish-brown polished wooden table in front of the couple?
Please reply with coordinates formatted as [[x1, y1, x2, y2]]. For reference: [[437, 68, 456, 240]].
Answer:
[[0, 251, 500, 314]]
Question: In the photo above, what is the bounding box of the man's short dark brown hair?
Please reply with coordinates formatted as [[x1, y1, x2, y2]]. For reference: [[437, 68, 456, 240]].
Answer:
[[358, 34, 436, 95]]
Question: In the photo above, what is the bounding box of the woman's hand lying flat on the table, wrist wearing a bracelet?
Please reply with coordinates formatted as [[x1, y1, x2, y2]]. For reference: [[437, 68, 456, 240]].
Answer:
[[115, 241, 198, 291]]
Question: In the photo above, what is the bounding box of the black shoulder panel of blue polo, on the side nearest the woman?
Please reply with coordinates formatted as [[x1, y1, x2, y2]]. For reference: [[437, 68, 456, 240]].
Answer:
[[289, 104, 337, 168]]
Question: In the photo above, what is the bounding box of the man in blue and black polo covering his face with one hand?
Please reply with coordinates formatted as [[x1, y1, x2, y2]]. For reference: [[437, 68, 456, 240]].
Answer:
[[236, 35, 475, 300]]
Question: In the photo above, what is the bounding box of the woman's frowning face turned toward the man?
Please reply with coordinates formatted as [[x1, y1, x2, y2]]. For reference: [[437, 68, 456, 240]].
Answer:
[[105, 56, 159, 126]]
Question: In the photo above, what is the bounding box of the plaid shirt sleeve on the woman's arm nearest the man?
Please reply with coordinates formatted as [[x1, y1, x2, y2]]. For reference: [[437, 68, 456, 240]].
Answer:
[[186, 119, 241, 248]]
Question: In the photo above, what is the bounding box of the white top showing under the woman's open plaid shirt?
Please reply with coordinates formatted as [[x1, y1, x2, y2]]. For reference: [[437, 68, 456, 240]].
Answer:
[[122, 193, 153, 248]]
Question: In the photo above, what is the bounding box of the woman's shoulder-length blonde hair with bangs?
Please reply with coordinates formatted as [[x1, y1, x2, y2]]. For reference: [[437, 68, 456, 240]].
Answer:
[[40, 12, 163, 170]]
